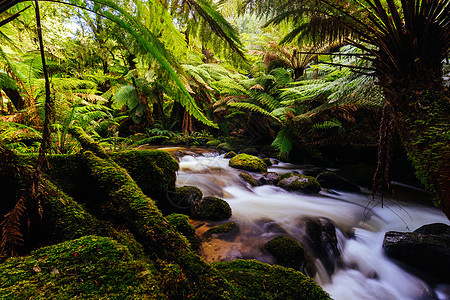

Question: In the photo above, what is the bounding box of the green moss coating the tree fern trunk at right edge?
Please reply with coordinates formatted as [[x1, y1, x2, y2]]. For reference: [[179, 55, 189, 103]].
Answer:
[[393, 88, 450, 217]]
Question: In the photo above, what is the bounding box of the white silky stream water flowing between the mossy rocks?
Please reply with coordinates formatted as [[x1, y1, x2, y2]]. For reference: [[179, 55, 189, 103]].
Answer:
[[171, 153, 450, 300]]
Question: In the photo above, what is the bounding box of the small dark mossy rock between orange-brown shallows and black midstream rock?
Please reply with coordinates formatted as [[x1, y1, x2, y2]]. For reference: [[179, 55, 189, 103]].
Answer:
[[264, 236, 305, 271]]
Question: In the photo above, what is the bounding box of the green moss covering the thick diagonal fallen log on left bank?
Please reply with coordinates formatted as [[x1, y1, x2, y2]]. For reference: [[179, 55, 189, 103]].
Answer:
[[83, 152, 237, 299]]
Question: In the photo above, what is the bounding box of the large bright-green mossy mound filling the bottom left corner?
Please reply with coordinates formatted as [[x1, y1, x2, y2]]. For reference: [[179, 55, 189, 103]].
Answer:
[[0, 236, 166, 299]]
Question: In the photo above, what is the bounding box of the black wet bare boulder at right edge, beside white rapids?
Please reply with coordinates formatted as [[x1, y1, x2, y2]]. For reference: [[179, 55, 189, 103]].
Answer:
[[383, 223, 450, 282]]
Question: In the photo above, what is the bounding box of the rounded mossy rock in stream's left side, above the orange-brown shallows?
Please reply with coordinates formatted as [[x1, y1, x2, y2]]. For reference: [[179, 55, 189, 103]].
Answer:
[[192, 197, 231, 221]]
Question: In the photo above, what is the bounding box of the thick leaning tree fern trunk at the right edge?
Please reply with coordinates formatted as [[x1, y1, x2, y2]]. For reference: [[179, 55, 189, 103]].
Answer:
[[384, 77, 450, 217]]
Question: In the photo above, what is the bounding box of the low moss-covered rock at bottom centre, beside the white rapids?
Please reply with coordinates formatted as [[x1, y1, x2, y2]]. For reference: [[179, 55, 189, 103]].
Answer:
[[212, 260, 331, 300]]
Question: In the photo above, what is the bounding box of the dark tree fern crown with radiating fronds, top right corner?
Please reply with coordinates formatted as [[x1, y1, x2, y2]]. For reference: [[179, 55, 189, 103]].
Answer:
[[246, 0, 450, 90]]
